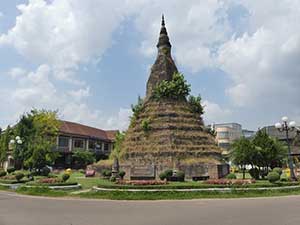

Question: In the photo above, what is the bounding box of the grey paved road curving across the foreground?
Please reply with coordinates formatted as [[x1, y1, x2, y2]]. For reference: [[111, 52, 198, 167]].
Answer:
[[0, 192, 300, 225]]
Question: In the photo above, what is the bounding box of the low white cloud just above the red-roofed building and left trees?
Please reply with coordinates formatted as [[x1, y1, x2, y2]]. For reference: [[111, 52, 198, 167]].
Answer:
[[0, 65, 130, 130]]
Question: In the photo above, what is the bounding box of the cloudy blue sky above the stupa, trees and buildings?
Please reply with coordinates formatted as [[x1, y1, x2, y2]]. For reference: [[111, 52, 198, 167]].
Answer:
[[0, 0, 300, 130]]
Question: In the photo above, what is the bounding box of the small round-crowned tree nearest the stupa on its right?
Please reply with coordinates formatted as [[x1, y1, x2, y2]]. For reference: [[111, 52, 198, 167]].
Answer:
[[229, 137, 255, 179]]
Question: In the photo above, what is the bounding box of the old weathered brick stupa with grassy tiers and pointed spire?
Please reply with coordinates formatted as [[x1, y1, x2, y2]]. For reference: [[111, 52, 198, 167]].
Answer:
[[121, 15, 229, 179]]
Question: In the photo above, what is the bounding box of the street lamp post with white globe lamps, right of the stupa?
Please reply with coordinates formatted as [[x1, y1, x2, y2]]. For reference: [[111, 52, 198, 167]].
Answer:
[[275, 116, 297, 181]]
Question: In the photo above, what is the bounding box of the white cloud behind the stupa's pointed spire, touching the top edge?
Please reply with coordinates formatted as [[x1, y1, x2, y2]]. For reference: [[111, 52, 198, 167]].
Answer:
[[132, 0, 230, 72]]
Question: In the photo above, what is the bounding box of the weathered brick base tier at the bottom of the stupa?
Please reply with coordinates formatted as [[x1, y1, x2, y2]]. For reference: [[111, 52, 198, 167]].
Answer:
[[120, 152, 229, 180]]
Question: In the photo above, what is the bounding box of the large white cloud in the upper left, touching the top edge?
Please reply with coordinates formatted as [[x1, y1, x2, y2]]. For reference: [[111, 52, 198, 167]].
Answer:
[[0, 0, 125, 81]]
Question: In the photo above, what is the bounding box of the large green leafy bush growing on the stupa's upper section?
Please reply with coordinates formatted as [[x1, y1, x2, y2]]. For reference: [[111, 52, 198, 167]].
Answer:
[[153, 73, 191, 100]]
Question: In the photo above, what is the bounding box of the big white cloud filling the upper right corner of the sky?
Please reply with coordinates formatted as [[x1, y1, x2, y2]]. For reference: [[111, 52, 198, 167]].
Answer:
[[218, 0, 300, 125]]
